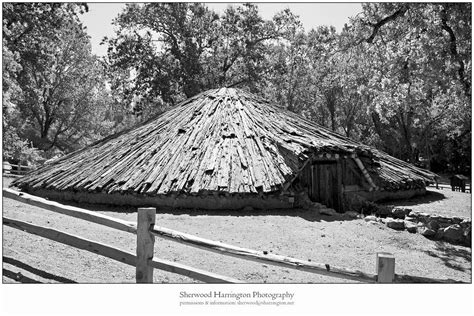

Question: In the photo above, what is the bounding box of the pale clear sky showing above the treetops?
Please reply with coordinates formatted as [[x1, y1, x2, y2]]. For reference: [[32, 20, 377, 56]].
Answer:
[[80, 2, 362, 56]]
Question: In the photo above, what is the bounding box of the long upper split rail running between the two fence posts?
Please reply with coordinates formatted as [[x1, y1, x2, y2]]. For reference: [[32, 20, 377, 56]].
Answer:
[[151, 225, 376, 283]]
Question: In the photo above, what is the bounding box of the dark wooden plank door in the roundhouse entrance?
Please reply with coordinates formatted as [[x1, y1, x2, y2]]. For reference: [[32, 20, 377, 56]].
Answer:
[[309, 161, 342, 211]]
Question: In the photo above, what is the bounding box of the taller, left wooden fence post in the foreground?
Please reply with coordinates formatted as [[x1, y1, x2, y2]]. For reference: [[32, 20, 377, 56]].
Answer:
[[135, 207, 156, 283]]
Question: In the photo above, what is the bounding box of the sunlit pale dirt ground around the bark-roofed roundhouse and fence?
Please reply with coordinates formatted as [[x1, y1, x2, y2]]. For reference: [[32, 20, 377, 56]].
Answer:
[[2, 178, 472, 283]]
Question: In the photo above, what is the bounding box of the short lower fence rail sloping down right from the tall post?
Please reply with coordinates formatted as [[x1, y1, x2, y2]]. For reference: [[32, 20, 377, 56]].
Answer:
[[148, 258, 245, 283]]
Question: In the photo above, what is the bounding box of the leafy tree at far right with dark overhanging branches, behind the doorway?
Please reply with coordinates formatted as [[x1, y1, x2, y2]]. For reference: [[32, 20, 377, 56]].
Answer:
[[351, 3, 471, 162]]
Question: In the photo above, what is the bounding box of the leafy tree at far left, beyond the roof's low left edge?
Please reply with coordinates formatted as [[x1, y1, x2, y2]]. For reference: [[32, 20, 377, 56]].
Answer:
[[3, 3, 112, 156]]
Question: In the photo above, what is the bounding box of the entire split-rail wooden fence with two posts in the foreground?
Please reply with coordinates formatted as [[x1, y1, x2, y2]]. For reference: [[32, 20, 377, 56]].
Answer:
[[3, 189, 458, 283]]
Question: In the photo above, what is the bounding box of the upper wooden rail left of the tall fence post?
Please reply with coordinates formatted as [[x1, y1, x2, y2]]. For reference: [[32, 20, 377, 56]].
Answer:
[[3, 188, 137, 234]]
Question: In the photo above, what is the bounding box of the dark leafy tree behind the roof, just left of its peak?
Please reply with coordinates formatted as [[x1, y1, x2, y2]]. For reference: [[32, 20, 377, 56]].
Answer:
[[104, 3, 218, 112]]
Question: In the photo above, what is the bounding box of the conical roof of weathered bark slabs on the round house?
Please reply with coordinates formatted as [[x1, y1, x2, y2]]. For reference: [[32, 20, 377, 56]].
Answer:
[[15, 88, 433, 196]]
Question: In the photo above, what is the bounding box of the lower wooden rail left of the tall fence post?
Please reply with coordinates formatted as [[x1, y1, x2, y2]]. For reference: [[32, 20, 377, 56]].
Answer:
[[3, 217, 137, 266]]
